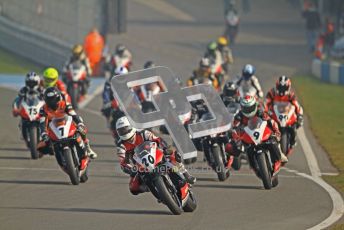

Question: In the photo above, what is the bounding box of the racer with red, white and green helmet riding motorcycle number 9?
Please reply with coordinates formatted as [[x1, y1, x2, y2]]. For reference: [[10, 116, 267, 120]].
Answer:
[[226, 95, 288, 172]]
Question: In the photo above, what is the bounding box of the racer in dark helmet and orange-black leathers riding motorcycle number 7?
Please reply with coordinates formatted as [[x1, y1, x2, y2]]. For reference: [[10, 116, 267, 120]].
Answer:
[[39, 87, 97, 159]]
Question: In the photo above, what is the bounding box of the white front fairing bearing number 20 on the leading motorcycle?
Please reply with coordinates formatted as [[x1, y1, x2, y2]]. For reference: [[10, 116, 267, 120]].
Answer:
[[133, 142, 157, 172]]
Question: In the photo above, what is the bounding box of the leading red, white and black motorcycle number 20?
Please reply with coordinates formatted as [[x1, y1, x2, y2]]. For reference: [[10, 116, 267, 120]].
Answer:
[[133, 141, 197, 215]]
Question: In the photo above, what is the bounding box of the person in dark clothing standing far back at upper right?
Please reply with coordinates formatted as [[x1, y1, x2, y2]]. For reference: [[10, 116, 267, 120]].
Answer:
[[302, 0, 321, 52]]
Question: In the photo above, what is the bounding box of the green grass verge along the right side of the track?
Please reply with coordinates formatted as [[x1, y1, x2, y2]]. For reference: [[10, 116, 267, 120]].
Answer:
[[293, 76, 344, 226]]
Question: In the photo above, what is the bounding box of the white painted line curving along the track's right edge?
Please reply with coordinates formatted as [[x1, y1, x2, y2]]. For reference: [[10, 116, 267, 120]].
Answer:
[[298, 127, 344, 230]]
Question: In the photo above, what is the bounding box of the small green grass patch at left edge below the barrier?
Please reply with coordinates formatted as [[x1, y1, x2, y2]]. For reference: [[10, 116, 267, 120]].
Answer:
[[0, 48, 42, 74]]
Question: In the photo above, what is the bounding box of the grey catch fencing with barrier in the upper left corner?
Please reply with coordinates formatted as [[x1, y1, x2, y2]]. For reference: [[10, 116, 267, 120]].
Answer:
[[0, 0, 109, 68]]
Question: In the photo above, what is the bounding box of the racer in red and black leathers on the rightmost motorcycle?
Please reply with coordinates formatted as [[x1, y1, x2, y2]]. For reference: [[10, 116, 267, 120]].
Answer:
[[264, 75, 303, 147]]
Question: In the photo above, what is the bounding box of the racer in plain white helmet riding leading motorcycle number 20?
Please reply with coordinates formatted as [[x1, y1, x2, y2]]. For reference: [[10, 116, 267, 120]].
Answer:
[[116, 117, 196, 195]]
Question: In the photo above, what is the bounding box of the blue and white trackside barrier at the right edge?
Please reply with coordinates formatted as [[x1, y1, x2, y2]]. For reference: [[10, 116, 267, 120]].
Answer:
[[312, 59, 344, 85]]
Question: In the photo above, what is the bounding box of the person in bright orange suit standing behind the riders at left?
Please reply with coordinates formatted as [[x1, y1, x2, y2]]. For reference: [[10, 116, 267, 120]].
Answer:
[[84, 28, 104, 75]]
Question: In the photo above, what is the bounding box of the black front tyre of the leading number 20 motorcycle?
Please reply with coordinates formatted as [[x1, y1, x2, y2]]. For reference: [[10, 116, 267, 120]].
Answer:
[[153, 176, 182, 215]]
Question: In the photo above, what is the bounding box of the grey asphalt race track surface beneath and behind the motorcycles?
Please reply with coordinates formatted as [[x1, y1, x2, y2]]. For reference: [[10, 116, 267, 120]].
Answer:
[[0, 0, 340, 230]]
